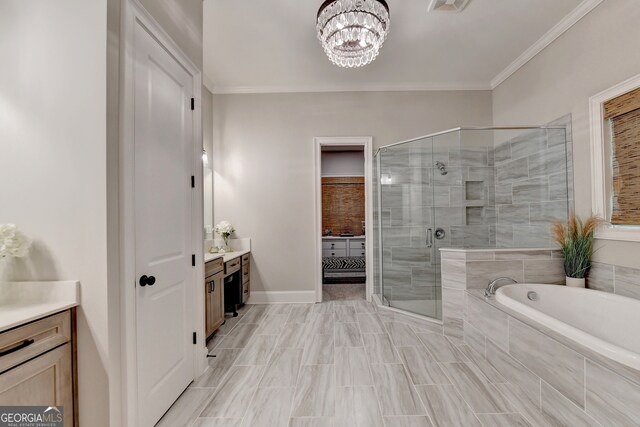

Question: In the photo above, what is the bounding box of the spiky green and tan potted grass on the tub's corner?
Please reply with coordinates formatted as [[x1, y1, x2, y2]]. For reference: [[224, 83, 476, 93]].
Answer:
[[552, 214, 602, 288]]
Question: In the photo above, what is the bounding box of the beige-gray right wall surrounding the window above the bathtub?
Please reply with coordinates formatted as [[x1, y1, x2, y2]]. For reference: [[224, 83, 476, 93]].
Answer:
[[493, 0, 640, 267]]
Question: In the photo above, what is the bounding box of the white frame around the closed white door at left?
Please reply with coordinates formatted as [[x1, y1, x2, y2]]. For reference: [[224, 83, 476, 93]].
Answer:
[[115, 0, 207, 427]]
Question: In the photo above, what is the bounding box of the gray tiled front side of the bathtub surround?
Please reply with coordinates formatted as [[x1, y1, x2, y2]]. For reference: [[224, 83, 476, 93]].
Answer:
[[464, 285, 640, 427]]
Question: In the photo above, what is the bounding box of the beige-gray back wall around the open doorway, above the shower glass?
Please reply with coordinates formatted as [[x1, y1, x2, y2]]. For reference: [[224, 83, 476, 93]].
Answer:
[[213, 91, 492, 291]]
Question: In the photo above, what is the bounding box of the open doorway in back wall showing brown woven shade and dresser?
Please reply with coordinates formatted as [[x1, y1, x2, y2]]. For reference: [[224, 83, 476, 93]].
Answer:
[[316, 138, 371, 301]]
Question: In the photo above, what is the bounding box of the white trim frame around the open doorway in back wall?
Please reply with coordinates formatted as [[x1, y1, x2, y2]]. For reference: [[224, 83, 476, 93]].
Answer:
[[313, 136, 374, 302]]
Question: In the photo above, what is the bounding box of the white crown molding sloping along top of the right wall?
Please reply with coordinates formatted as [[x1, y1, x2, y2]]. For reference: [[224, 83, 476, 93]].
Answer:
[[490, 0, 604, 90]]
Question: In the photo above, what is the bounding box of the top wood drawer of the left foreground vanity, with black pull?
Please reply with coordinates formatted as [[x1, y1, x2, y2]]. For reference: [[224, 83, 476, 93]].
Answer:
[[0, 310, 71, 372]]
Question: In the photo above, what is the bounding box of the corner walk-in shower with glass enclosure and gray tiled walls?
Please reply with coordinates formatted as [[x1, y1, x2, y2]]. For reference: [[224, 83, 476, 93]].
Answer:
[[374, 127, 571, 319]]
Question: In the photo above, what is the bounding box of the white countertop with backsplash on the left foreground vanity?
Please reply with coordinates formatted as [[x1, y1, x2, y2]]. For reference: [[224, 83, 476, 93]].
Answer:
[[0, 281, 80, 332]]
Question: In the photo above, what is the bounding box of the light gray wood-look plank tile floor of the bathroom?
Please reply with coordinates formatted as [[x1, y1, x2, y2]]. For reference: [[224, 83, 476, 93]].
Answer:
[[158, 300, 538, 427]]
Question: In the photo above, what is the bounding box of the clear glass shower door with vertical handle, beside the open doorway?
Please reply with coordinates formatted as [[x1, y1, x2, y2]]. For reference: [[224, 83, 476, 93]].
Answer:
[[378, 138, 441, 319]]
